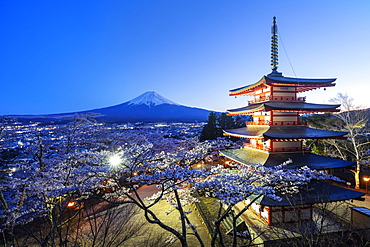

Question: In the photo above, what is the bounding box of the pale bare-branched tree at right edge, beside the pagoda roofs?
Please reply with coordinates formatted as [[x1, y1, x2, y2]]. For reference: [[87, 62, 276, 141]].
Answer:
[[307, 93, 370, 189]]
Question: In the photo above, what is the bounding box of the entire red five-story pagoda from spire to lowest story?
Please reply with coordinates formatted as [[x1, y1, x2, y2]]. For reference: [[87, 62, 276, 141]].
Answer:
[[221, 17, 364, 228]]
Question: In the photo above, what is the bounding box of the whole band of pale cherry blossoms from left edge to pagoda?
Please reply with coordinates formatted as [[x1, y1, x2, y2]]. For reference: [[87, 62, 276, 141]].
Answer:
[[0, 121, 342, 247]]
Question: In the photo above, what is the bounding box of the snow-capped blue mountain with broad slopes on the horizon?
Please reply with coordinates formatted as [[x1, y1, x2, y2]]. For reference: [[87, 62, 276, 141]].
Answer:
[[11, 91, 212, 123]]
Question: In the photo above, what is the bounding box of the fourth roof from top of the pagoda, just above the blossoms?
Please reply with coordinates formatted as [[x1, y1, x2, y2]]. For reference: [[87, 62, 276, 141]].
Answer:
[[220, 148, 356, 170]]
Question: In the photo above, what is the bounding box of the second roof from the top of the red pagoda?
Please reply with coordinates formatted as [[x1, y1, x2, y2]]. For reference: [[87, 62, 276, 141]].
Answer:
[[227, 101, 340, 115]]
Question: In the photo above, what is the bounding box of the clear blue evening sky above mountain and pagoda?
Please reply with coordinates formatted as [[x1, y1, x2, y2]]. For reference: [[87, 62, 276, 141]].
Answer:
[[0, 0, 370, 115]]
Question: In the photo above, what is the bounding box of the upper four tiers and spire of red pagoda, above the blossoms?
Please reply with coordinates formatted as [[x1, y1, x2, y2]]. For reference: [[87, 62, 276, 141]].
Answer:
[[221, 17, 354, 169]]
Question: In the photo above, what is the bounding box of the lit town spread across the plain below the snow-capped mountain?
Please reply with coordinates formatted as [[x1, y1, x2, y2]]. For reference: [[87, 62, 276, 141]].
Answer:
[[0, 122, 204, 176]]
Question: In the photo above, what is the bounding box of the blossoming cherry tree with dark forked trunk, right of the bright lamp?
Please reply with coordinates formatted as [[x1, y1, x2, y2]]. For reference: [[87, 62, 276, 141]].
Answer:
[[99, 143, 209, 246]]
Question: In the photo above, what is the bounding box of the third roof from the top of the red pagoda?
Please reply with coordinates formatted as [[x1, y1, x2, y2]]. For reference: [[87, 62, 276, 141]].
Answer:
[[224, 125, 347, 139]]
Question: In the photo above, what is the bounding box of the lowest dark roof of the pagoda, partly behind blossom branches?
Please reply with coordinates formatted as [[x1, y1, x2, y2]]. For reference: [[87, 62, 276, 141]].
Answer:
[[249, 180, 365, 206]]
